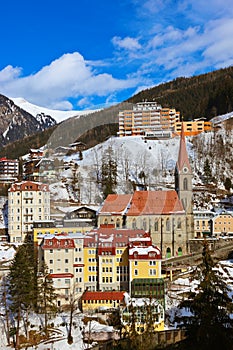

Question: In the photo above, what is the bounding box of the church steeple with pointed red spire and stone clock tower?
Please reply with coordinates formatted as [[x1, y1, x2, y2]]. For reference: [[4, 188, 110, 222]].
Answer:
[[175, 124, 193, 214]]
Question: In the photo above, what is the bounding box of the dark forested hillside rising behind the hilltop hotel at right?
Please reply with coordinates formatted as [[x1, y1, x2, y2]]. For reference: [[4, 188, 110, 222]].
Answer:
[[128, 67, 233, 120]]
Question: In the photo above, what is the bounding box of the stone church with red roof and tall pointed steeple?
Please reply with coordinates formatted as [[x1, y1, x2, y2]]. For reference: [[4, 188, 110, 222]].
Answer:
[[98, 129, 194, 258]]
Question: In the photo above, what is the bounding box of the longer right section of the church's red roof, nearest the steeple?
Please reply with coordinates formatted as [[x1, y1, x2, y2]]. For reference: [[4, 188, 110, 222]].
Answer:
[[127, 190, 184, 216]]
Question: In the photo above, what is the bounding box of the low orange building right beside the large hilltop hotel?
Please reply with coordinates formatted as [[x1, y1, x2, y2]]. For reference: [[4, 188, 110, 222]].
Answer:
[[175, 120, 212, 136]]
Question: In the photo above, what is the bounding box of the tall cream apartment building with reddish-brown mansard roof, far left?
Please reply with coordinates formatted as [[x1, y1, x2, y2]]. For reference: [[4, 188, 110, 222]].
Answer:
[[8, 181, 50, 242]]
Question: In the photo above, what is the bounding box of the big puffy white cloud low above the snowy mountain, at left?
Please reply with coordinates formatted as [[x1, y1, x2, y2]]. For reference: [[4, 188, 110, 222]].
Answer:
[[0, 52, 135, 109]]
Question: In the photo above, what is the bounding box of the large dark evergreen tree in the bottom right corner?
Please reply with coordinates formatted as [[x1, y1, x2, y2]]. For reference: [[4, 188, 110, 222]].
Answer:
[[177, 241, 233, 350]]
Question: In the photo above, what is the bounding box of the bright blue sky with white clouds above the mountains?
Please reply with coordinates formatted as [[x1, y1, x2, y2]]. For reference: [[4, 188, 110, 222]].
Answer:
[[0, 0, 233, 110]]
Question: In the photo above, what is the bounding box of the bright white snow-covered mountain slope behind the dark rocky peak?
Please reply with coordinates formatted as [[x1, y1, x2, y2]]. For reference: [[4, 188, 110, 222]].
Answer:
[[11, 97, 98, 123]]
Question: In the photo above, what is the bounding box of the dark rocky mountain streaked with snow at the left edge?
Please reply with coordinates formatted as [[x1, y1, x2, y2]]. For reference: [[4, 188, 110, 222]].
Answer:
[[0, 95, 57, 148]]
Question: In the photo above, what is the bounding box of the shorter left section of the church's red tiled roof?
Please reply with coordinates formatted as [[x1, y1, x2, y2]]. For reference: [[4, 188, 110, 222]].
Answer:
[[100, 194, 132, 215]]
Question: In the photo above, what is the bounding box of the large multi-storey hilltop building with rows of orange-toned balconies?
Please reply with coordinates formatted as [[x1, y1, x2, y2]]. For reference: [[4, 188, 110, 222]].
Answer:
[[118, 102, 180, 137]]
